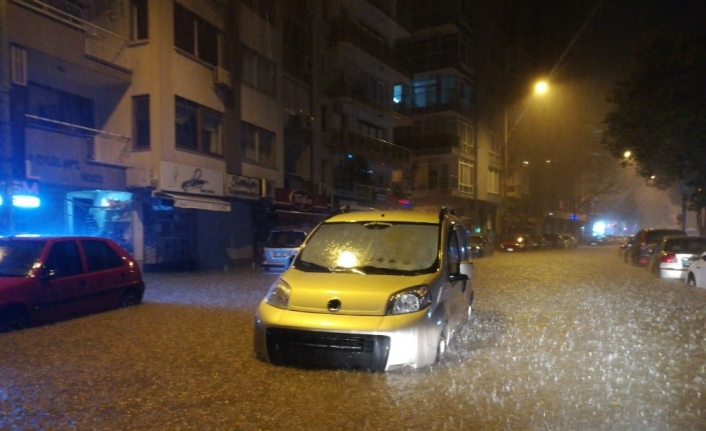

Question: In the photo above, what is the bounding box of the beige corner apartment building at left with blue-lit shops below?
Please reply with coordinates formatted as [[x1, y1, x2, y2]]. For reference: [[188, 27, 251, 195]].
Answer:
[[0, 0, 258, 270]]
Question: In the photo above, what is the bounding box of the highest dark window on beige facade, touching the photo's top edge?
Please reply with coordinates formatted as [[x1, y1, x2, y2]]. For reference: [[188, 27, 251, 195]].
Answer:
[[174, 3, 218, 66]]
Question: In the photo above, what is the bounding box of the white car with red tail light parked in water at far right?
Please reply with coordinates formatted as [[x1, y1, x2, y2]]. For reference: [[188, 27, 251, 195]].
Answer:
[[645, 236, 706, 280]]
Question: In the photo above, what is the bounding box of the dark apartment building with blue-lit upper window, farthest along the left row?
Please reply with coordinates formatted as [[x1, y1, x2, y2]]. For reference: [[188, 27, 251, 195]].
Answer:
[[394, 0, 486, 233]]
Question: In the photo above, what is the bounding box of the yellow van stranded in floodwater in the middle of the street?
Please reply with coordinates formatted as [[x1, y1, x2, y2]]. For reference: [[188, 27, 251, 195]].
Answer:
[[254, 209, 473, 371]]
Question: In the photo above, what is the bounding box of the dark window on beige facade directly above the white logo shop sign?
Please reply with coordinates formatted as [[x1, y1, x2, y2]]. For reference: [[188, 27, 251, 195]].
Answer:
[[175, 96, 223, 156]]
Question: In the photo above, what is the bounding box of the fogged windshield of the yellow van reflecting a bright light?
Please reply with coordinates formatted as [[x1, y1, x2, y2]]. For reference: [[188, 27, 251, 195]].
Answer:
[[297, 221, 439, 273]]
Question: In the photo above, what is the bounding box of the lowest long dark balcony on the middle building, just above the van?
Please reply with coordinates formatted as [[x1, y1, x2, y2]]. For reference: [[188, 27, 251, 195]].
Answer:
[[328, 130, 410, 164]]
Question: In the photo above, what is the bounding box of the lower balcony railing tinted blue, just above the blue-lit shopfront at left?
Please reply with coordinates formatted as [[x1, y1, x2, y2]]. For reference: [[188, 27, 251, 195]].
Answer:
[[25, 114, 131, 167]]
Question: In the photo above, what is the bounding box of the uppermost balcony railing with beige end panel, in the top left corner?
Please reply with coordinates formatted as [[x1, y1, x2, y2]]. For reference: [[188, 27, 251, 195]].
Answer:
[[12, 0, 131, 70]]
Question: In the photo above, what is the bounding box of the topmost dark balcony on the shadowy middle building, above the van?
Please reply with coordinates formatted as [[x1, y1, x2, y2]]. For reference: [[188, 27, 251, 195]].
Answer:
[[329, 17, 410, 76]]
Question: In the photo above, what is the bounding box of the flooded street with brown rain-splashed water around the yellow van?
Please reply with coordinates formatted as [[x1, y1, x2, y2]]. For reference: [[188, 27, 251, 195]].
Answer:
[[0, 246, 706, 431]]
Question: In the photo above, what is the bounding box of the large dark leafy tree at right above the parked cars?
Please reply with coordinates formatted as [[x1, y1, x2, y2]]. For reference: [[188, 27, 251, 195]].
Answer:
[[603, 29, 706, 234]]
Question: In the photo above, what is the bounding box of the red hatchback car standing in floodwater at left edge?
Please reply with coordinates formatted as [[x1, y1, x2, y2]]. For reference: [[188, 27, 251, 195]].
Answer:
[[0, 236, 145, 332]]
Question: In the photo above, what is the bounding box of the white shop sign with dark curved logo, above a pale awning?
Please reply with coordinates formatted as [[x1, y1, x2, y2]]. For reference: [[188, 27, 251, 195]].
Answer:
[[159, 161, 223, 196]]
